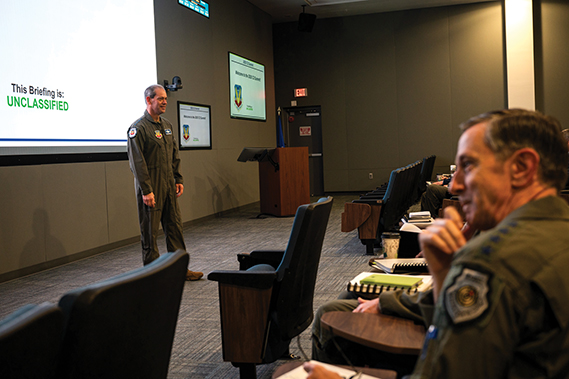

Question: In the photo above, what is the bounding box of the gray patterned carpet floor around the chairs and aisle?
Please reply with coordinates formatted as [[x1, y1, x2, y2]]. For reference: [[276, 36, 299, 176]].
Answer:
[[0, 194, 382, 379]]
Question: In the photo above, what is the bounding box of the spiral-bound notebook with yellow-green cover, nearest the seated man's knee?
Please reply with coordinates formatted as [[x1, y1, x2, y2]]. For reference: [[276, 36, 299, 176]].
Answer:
[[347, 272, 432, 297]]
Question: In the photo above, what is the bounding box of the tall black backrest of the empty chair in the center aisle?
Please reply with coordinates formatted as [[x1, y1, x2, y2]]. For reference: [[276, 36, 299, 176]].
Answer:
[[276, 197, 333, 339]]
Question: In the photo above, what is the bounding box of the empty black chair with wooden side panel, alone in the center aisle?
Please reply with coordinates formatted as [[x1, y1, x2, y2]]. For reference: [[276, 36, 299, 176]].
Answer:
[[208, 197, 333, 379]]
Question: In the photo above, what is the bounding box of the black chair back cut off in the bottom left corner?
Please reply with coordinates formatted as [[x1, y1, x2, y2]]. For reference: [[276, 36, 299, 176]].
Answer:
[[0, 302, 63, 379]]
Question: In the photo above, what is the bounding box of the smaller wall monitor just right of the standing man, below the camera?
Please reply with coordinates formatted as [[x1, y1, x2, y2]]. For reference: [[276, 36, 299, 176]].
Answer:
[[178, 101, 211, 149]]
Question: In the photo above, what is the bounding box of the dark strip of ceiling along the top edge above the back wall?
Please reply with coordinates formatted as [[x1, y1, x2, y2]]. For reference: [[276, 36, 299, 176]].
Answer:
[[248, 0, 498, 23]]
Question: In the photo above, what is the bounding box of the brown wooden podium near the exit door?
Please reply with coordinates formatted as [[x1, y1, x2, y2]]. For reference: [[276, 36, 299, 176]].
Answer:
[[259, 147, 310, 216]]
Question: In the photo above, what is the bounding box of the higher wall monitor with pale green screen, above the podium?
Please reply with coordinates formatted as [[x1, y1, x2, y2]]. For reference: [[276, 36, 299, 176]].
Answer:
[[229, 53, 267, 121]]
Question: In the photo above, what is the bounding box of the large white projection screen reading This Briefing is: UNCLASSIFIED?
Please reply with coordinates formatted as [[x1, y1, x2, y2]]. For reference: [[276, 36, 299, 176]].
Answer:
[[0, 0, 157, 165]]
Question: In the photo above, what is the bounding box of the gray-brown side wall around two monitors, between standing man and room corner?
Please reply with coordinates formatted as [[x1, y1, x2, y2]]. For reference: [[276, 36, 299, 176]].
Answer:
[[155, 0, 276, 217]]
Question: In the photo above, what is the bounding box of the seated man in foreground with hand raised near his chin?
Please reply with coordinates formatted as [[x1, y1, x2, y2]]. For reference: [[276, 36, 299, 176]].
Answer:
[[305, 110, 569, 378]]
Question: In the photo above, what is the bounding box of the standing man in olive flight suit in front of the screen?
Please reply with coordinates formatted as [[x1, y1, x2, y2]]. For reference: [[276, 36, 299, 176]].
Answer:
[[127, 84, 203, 280]]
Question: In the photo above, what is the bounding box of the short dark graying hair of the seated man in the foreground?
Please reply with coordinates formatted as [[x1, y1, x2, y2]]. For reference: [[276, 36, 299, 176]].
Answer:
[[460, 109, 568, 190]]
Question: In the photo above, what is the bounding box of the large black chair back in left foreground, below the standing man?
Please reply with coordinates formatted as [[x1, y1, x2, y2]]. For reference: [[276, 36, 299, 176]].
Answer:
[[58, 250, 189, 379]]
